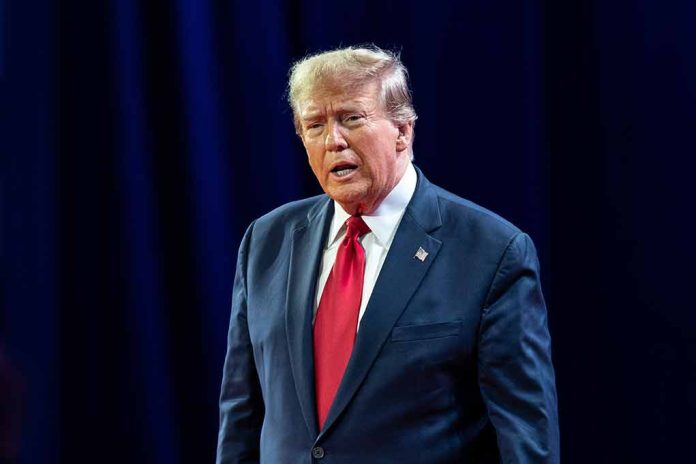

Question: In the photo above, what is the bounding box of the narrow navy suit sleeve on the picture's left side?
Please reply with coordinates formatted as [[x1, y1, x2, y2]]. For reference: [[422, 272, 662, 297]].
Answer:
[[216, 224, 264, 464]]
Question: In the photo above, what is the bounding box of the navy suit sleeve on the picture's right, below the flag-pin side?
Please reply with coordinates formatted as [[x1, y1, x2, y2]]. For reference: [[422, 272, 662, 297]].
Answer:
[[478, 233, 560, 464]]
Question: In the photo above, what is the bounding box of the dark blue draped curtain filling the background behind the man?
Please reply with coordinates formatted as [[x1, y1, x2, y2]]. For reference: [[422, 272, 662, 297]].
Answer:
[[0, 0, 696, 464]]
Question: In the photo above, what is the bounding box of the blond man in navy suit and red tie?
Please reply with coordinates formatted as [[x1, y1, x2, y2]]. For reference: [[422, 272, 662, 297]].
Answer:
[[217, 48, 559, 464]]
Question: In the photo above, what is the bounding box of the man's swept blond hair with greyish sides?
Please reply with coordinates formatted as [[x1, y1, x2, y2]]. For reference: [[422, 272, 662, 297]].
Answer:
[[288, 45, 418, 134]]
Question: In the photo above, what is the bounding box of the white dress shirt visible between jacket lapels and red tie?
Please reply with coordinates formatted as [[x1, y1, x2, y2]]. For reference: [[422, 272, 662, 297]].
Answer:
[[314, 163, 418, 330]]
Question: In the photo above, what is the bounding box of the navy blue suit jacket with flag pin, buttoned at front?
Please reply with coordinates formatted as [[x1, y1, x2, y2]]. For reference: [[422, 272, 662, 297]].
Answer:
[[217, 171, 559, 464]]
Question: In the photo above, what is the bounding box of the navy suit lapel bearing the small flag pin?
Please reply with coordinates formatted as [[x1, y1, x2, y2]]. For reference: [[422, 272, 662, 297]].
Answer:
[[321, 171, 442, 435]]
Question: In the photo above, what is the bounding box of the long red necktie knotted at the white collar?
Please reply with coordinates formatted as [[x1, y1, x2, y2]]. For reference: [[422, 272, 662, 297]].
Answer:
[[314, 216, 370, 429]]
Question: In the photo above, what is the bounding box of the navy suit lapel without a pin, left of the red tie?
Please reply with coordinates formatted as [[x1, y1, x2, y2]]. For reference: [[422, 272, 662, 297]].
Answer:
[[285, 199, 333, 437]]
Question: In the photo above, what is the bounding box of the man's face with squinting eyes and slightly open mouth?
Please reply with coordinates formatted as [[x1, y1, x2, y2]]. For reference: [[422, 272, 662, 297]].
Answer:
[[298, 83, 412, 214]]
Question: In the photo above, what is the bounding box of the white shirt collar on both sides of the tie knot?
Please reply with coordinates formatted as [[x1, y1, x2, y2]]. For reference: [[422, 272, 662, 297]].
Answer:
[[326, 163, 418, 249]]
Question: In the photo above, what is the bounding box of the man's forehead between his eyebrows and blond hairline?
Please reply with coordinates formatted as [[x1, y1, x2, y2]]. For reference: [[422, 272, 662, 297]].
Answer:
[[298, 82, 381, 118]]
